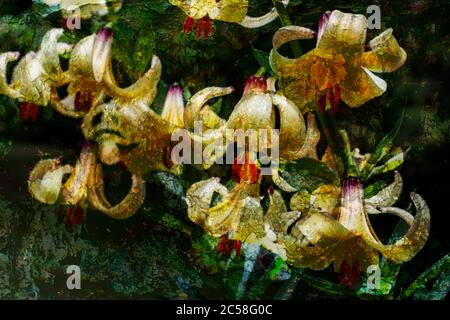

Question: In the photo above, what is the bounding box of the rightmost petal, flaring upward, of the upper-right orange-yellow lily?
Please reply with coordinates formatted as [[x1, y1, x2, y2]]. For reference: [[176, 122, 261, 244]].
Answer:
[[361, 29, 407, 72]]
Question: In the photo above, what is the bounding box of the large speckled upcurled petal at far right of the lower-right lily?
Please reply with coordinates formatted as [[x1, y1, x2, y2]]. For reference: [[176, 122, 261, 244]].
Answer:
[[363, 193, 431, 263]]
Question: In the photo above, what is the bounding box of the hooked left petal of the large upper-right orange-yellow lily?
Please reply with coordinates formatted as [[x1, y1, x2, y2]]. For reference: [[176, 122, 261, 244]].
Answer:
[[269, 26, 316, 72]]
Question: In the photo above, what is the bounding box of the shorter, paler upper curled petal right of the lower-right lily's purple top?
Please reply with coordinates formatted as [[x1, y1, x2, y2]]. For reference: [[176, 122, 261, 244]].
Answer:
[[364, 172, 403, 214]]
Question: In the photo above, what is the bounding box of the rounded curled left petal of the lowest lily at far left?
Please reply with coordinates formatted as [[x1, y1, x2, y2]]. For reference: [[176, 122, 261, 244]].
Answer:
[[28, 159, 72, 204]]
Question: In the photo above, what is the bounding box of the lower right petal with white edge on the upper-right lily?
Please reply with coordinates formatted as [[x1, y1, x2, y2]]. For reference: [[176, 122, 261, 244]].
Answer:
[[341, 67, 387, 108]]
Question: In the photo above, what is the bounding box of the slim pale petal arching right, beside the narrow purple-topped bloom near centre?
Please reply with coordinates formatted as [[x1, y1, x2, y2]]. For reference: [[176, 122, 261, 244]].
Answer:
[[184, 87, 234, 129]]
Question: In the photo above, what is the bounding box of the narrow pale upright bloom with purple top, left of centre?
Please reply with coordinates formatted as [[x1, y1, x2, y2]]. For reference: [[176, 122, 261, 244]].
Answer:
[[161, 83, 184, 128]]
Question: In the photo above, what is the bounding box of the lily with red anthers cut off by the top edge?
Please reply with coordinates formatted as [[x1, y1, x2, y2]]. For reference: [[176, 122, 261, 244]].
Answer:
[[169, 0, 289, 38]]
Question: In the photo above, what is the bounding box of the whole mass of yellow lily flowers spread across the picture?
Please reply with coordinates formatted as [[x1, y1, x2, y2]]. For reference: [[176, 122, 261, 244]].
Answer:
[[0, 0, 430, 285]]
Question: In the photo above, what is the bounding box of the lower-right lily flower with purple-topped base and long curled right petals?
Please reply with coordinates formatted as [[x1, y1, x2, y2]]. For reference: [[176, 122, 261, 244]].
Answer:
[[277, 173, 430, 284]]
